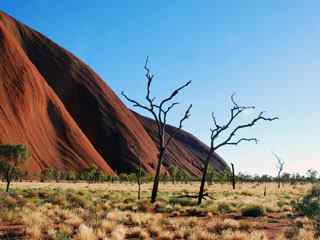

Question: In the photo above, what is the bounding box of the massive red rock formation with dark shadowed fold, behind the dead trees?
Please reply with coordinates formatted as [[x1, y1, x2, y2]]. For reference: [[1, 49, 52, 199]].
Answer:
[[0, 12, 228, 174]]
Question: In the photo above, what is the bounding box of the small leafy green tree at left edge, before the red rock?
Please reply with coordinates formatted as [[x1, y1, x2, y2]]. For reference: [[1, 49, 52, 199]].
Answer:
[[0, 144, 28, 192]]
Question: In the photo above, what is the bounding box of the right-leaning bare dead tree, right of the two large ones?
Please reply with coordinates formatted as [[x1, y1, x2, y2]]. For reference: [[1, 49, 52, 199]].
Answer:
[[198, 94, 278, 205]]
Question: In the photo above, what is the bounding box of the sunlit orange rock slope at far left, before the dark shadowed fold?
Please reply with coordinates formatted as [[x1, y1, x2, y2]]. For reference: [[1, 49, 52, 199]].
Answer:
[[0, 16, 114, 174]]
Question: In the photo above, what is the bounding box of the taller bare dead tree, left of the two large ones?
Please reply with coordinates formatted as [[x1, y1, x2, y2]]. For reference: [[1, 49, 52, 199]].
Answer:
[[121, 57, 192, 203]]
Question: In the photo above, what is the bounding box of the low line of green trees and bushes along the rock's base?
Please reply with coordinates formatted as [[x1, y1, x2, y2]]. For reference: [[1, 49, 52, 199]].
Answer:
[[0, 154, 320, 190]]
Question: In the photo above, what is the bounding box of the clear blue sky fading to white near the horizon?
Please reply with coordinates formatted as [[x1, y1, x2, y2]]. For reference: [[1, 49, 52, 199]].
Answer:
[[0, 0, 320, 175]]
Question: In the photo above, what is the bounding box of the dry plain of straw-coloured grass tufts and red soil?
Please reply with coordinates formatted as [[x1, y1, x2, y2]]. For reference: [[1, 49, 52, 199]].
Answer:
[[0, 182, 314, 240]]
